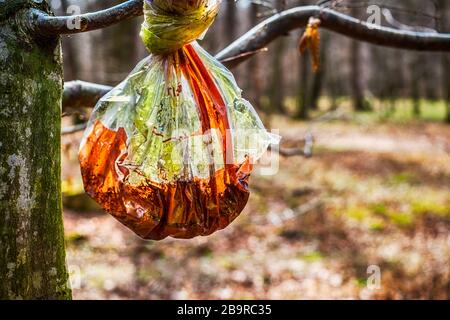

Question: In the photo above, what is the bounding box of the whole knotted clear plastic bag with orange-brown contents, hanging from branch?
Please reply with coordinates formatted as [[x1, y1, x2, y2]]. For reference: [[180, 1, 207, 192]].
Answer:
[[79, 0, 277, 240]]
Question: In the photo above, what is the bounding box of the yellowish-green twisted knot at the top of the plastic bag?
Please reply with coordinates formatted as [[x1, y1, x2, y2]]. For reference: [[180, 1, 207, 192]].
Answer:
[[140, 0, 221, 54]]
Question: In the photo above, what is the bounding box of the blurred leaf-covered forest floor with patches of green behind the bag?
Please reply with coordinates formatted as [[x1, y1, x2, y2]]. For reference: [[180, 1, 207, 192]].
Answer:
[[64, 118, 450, 299]]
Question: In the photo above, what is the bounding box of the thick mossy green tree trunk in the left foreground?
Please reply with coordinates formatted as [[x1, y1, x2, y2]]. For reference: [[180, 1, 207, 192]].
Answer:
[[0, 0, 71, 299]]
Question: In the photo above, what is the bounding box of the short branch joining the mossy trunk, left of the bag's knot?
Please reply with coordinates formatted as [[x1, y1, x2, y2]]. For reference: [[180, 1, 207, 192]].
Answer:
[[29, 0, 143, 36]]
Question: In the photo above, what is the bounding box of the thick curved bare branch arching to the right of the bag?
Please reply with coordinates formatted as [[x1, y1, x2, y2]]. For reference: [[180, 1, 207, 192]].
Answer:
[[216, 6, 450, 67]]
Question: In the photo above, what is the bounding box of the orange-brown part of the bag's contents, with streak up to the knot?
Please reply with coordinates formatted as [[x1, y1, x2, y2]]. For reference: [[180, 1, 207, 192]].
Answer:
[[79, 45, 252, 240]]
